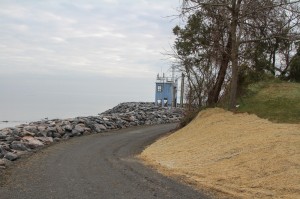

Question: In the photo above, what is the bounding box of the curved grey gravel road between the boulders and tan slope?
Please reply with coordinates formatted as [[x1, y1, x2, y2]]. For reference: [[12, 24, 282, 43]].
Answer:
[[0, 124, 207, 199]]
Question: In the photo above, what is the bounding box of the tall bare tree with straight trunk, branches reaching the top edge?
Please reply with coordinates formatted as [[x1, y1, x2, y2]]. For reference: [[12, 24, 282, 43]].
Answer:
[[182, 0, 300, 109]]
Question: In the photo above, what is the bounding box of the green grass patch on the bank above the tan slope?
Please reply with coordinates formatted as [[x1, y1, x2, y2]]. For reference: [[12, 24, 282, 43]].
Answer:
[[237, 82, 300, 123]]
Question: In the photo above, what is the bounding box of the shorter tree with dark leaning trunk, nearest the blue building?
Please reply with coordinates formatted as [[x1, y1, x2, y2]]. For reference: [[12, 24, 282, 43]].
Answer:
[[170, 11, 231, 106]]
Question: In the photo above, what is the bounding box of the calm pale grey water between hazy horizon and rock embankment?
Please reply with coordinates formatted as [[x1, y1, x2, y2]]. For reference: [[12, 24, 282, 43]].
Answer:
[[0, 71, 154, 128]]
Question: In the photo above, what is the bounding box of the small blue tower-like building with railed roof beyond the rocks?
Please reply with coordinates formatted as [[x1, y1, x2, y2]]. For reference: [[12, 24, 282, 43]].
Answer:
[[155, 74, 177, 107]]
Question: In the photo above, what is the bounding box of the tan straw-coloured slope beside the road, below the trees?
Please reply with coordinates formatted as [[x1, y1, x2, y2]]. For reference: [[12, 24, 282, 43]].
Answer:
[[140, 108, 300, 199]]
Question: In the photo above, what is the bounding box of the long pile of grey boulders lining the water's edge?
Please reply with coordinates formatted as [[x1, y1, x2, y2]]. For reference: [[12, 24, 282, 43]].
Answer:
[[0, 102, 183, 169]]
